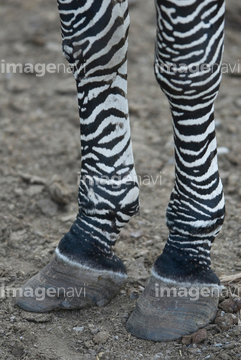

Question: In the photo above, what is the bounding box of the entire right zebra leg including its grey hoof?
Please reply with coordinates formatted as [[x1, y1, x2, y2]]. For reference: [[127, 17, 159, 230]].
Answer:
[[127, 0, 225, 341]]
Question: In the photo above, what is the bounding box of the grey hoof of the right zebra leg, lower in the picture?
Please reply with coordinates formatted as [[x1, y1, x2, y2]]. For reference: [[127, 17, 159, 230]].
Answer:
[[126, 273, 220, 341]]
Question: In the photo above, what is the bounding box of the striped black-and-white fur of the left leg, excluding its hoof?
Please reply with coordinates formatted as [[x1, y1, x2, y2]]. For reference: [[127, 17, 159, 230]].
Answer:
[[58, 0, 139, 270]]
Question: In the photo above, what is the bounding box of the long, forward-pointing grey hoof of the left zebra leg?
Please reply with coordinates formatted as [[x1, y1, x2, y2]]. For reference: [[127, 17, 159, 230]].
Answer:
[[17, 255, 127, 312]]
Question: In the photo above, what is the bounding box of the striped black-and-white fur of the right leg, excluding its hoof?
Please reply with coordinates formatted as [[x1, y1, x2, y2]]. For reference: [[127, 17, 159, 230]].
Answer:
[[155, 0, 225, 276]]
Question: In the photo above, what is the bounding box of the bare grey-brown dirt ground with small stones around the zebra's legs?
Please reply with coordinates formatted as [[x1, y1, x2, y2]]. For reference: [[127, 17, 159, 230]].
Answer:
[[0, 0, 241, 360]]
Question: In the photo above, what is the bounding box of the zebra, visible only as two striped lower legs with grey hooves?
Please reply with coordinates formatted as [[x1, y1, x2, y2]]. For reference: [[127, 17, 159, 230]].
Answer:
[[17, 0, 225, 341]]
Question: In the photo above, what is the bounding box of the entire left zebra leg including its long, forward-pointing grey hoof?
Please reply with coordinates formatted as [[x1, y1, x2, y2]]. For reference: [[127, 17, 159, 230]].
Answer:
[[18, 0, 139, 312]]
